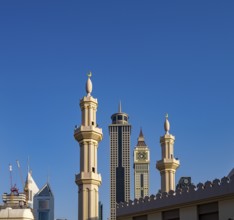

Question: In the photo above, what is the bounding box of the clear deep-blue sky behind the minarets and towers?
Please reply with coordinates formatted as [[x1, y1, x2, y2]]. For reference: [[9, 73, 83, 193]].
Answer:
[[0, 0, 234, 220]]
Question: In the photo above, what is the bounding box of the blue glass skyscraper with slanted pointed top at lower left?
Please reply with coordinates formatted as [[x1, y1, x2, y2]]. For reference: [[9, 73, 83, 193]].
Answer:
[[33, 183, 54, 220]]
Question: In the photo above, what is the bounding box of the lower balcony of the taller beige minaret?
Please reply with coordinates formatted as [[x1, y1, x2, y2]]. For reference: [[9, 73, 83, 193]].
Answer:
[[75, 172, 102, 186]]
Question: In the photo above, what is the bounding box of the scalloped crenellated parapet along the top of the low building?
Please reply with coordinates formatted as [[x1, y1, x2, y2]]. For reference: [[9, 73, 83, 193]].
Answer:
[[116, 175, 234, 217]]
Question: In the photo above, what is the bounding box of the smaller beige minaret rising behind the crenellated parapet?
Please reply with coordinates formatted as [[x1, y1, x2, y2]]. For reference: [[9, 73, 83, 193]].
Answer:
[[156, 115, 180, 192]]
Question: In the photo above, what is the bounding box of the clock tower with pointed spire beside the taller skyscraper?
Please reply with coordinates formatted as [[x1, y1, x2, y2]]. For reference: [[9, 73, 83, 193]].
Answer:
[[133, 129, 150, 199]]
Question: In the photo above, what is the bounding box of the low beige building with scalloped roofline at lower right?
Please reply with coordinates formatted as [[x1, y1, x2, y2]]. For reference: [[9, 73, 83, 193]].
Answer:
[[117, 175, 234, 220]]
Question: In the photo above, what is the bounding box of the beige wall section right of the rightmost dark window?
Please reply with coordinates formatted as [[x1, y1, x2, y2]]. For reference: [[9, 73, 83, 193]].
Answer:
[[219, 198, 234, 220]]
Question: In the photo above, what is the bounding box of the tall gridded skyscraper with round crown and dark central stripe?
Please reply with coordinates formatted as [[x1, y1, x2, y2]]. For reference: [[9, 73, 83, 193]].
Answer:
[[109, 103, 131, 220]]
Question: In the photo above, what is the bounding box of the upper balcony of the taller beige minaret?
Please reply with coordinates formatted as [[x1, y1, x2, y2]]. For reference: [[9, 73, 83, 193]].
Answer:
[[74, 125, 103, 142]]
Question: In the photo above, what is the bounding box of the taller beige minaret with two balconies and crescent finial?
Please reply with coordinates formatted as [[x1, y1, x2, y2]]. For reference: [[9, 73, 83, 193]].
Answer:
[[74, 73, 102, 220]]
